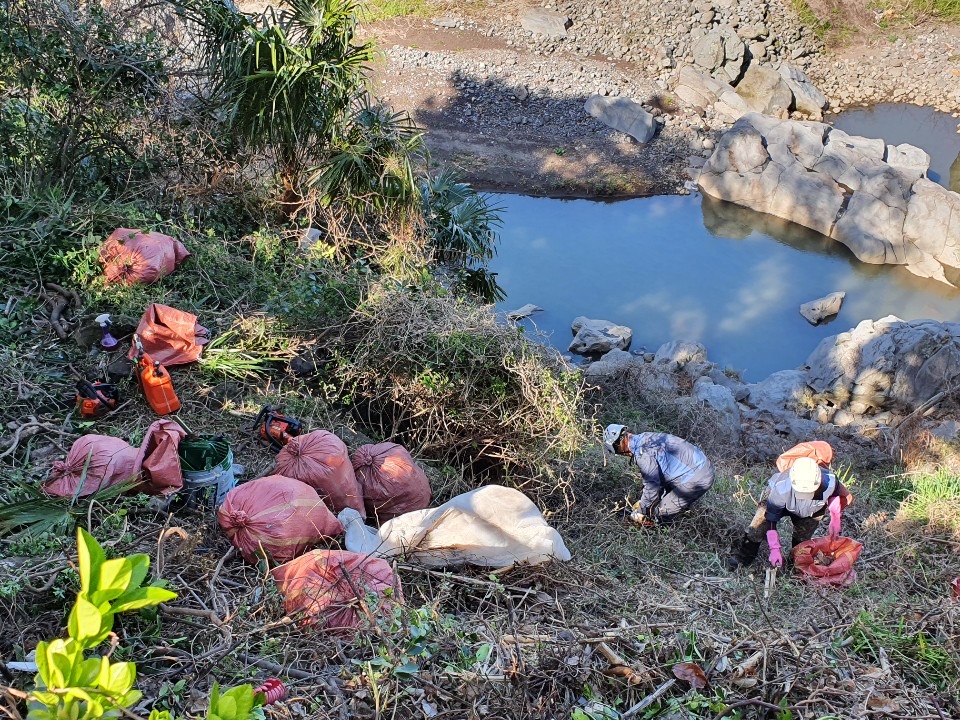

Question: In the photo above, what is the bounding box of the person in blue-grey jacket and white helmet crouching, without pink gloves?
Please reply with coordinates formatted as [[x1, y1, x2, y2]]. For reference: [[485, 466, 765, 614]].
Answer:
[[603, 425, 714, 525]]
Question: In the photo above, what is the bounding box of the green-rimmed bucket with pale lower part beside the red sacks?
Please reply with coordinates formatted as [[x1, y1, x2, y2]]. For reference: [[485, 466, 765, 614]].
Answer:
[[177, 435, 243, 510]]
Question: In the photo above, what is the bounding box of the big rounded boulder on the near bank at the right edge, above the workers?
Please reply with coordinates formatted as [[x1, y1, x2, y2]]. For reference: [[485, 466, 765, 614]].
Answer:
[[806, 315, 960, 414]]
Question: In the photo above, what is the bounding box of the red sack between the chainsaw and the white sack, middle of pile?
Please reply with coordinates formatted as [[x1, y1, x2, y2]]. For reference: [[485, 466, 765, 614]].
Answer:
[[275, 430, 367, 517]]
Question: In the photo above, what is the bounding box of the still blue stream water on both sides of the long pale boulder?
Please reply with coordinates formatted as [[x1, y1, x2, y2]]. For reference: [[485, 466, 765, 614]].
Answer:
[[490, 105, 960, 381]]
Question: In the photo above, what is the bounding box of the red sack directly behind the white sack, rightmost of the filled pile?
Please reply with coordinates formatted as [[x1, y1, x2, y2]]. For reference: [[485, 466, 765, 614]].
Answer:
[[352, 443, 430, 521]]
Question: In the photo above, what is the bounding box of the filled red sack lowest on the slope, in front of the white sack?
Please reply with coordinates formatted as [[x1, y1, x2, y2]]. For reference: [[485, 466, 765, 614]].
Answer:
[[273, 550, 403, 634]]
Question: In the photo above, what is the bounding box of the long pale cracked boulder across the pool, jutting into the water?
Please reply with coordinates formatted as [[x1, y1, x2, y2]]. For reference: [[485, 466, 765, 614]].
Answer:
[[697, 112, 960, 283]]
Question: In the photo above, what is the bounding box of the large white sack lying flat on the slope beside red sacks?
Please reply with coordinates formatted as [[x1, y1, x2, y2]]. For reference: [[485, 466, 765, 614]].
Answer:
[[337, 485, 570, 567]]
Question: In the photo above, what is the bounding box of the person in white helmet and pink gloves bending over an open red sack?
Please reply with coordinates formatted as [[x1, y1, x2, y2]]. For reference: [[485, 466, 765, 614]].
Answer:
[[726, 457, 853, 570]]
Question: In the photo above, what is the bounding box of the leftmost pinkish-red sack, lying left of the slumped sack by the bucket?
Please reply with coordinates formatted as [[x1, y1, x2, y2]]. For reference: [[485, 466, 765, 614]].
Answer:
[[43, 435, 139, 497]]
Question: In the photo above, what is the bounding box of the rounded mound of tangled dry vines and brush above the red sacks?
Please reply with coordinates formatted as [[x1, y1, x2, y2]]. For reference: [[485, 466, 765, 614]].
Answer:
[[331, 290, 590, 470]]
